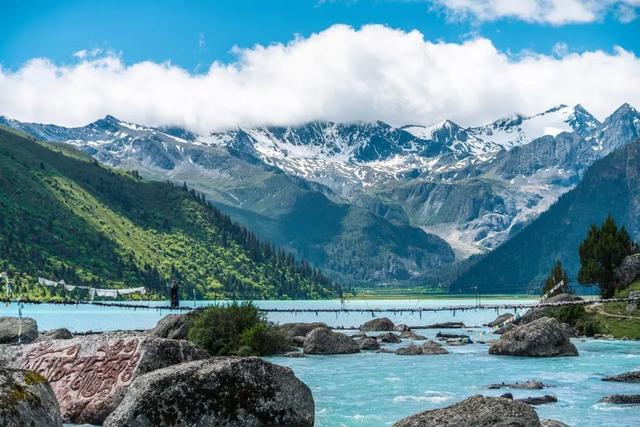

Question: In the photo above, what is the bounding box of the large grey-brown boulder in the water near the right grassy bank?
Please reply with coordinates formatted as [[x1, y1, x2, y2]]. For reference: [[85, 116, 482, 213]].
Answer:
[[489, 317, 578, 357]]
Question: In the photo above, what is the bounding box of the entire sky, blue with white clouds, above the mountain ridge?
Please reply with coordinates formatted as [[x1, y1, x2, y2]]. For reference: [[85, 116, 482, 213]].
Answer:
[[0, 0, 640, 132]]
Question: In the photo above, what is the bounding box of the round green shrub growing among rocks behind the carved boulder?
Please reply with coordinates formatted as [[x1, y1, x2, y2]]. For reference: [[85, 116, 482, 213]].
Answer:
[[187, 302, 286, 356]]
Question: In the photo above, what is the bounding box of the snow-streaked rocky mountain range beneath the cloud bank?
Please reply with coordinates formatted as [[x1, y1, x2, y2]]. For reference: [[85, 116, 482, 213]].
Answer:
[[0, 104, 640, 290]]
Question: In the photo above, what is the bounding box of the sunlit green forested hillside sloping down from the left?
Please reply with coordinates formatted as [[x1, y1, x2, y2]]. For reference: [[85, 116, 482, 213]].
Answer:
[[0, 128, 340, 298]]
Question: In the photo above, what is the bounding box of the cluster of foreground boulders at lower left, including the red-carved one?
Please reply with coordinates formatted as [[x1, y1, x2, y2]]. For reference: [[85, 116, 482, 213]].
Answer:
[[0, 316, 314, 427]]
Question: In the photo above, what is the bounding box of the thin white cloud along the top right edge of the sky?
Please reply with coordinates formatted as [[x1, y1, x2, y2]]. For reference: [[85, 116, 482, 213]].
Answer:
[[432, 0, 640, 25]]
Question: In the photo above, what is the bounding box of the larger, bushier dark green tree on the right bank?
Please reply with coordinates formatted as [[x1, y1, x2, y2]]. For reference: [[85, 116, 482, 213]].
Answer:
[[578, 215, 638, 298]]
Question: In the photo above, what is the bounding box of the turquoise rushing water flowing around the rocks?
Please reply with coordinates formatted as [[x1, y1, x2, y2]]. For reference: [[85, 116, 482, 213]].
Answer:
[[0, 299, 640, 426]]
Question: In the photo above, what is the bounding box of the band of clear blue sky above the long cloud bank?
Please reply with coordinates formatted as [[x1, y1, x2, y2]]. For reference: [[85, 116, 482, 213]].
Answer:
[[0, 0, 640, 71]]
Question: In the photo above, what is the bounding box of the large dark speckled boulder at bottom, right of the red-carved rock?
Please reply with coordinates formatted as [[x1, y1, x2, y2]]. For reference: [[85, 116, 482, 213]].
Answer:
[[104, 357, 315, 427]]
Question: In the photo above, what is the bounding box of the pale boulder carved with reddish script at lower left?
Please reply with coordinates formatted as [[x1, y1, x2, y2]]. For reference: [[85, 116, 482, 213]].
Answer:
[[0, 332, 208, 424]]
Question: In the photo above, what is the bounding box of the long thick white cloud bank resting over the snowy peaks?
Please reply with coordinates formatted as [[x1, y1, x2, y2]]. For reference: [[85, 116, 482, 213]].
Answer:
[[0, 25, 640, 132]]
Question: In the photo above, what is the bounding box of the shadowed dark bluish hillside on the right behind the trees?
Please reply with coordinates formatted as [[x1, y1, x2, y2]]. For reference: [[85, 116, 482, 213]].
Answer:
[[452, 141, 640, 293]]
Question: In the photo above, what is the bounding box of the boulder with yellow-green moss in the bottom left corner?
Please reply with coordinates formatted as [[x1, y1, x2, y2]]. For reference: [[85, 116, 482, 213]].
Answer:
[[0, 368, 62, 427]]
